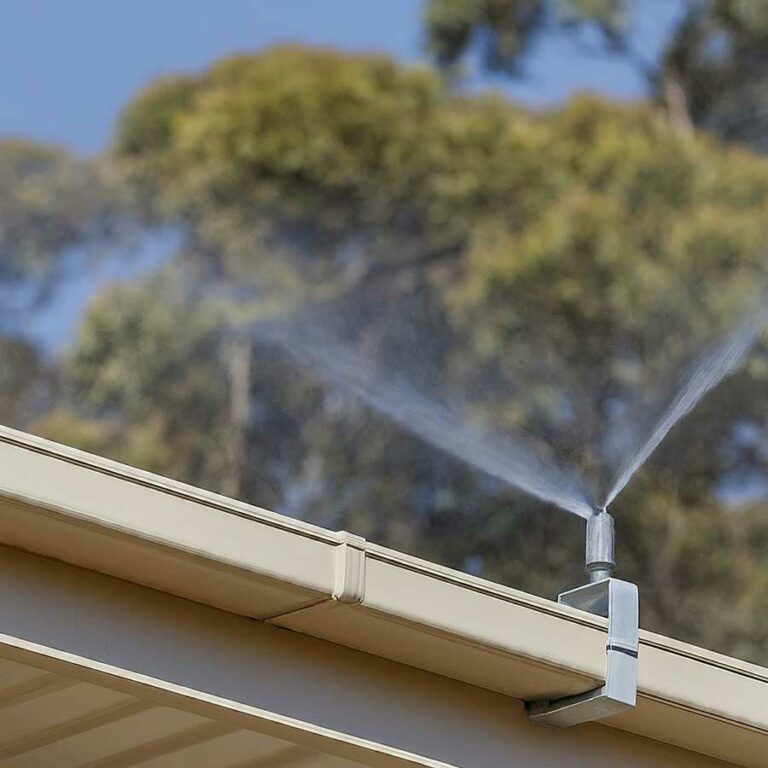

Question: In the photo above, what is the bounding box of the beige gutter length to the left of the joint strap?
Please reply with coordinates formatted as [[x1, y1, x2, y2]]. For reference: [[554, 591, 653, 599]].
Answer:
[[0, 428, 340, 618]]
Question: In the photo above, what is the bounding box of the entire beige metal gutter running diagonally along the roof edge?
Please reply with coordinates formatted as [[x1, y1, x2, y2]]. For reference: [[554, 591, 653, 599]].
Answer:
[[0, 428, 768, 766]]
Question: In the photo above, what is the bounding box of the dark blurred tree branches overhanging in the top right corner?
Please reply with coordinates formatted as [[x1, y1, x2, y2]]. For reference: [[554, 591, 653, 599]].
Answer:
[[425, 0, 768, 150]]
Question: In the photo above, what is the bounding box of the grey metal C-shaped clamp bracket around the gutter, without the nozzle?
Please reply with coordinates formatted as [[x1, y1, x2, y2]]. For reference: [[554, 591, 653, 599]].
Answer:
[[525, 578, 639, 728]]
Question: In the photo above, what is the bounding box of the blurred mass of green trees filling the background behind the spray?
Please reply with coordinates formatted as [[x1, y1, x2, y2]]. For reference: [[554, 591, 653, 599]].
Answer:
[[0, 6, 768, 662]]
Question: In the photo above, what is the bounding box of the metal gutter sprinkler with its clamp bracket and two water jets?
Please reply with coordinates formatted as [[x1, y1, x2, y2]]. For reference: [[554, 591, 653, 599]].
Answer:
[[254, 290, 768, 727]]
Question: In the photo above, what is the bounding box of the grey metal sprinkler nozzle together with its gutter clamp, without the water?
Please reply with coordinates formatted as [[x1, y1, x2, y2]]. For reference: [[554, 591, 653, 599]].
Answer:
[[525, 508, 639, 728]]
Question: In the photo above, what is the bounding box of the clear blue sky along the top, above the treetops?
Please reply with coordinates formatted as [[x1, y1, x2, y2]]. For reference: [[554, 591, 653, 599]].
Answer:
[[0, 0, 680, 152]]
